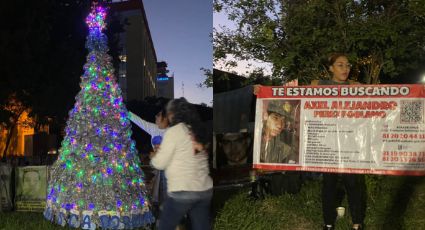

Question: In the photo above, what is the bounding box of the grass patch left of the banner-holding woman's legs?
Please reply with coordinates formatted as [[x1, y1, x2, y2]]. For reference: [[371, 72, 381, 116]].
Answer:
[[214, 182, 321, 229]]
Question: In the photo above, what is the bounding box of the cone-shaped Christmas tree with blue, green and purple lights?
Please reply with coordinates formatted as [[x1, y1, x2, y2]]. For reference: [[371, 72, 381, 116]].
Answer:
[[44, 3, 154, 229]]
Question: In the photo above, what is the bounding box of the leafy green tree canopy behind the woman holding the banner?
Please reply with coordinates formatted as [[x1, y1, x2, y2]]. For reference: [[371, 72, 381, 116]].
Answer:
[[214, 0, 425, 83]]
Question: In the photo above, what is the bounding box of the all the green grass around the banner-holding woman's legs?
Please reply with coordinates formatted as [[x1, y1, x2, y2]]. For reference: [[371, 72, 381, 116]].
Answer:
[[214, 175, 425, 230]]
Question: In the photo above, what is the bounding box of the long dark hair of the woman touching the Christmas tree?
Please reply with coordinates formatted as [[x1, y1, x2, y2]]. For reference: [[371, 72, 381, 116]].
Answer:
[[167, 97, 209, 146]]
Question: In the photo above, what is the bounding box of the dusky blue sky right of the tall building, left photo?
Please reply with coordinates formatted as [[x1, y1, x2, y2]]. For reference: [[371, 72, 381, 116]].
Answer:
[[143, 0, 213, 105]]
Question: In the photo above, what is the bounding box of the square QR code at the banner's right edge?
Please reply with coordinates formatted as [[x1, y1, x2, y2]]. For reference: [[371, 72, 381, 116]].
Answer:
[[400, 101, 424, 124]]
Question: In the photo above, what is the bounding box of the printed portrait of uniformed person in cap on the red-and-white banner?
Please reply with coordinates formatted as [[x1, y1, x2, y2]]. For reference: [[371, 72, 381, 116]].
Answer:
[[260, 100, 300, 164]]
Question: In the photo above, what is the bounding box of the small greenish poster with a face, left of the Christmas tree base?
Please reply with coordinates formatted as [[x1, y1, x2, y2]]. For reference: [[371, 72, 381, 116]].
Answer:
[[15, 166, 47, 212]]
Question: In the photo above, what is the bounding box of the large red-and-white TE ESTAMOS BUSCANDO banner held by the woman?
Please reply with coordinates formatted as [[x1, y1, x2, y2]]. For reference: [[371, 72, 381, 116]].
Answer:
[[253, 85, 425, 175]]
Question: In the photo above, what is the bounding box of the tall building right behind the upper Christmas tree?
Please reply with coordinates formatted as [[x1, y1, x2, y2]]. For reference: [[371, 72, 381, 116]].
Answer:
[[110, 0, 157, 101]]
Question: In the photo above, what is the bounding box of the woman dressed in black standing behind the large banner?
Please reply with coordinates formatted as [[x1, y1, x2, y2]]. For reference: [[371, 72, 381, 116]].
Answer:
[[311, 53, 365, 230]]
